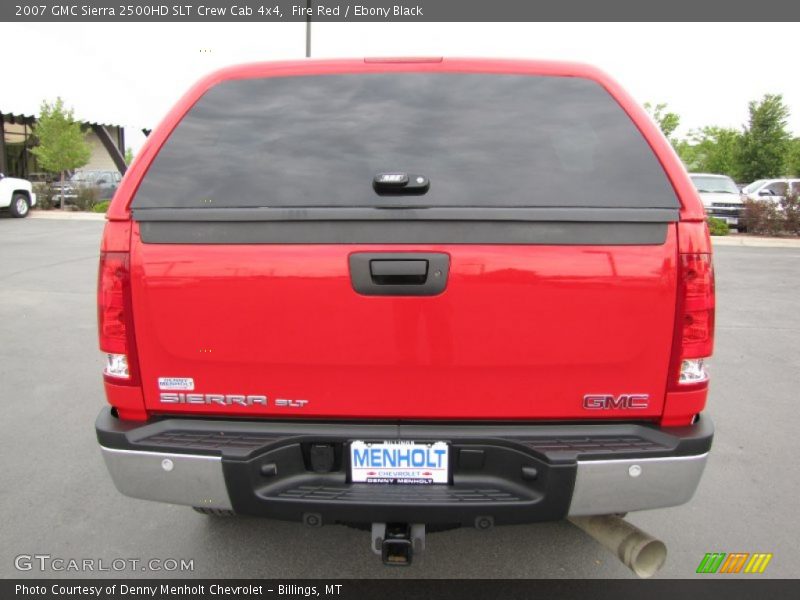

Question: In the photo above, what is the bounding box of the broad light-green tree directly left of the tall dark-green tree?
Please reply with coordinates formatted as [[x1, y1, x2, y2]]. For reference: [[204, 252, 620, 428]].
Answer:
[[678, 126, 743, 180]]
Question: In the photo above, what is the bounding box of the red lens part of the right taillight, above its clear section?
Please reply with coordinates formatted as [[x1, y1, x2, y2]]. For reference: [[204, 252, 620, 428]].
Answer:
[[680, 254, 714, 358]]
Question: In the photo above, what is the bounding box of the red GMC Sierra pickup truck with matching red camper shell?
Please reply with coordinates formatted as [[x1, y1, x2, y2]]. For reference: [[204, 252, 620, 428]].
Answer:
[[96, 59, 714, 564]]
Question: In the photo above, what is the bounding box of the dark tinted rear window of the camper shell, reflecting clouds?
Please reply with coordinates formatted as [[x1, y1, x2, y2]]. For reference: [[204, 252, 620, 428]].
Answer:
[[133, 73, 678, 208]]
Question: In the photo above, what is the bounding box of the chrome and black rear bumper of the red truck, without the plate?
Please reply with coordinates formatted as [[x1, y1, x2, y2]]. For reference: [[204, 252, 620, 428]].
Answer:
[[96, 409, 714, 526]]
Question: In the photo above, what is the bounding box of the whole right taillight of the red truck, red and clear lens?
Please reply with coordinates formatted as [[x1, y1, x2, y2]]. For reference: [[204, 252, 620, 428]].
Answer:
[[677, 253, 714, 387]]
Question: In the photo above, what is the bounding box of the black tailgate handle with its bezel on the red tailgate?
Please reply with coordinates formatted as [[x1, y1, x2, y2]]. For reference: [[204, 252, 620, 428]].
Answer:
[[350, 252, 450, 296]]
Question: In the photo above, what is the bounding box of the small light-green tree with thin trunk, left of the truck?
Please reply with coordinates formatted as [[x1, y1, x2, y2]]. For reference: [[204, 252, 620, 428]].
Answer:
[[32, 98, 91, 209]]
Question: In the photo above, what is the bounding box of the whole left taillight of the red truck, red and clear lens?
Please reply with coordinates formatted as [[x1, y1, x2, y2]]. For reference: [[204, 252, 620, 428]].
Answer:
[[97, 252, 136, 384]]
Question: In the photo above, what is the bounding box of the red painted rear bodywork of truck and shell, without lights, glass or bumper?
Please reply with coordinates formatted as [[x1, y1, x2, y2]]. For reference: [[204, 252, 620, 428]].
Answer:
[[98, 59, 710, 425]]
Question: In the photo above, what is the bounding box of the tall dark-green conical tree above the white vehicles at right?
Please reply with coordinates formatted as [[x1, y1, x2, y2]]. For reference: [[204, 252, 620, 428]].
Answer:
[[739, 94, 791, 181]]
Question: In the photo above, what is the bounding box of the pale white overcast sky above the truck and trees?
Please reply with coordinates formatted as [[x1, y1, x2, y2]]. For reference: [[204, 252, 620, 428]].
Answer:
[[0, 23, 800, 150]]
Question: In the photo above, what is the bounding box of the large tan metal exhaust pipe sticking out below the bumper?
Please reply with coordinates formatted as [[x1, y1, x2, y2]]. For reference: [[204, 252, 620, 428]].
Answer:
[[569, 515, 667, 579]]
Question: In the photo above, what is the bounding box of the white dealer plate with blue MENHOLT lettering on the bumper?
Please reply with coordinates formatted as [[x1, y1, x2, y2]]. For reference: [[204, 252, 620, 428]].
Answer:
[[350, 440, 450, 485]]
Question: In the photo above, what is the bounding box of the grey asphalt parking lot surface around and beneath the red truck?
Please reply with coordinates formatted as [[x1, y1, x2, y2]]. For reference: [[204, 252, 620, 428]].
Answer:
[[0, 217, 800, 578]]
